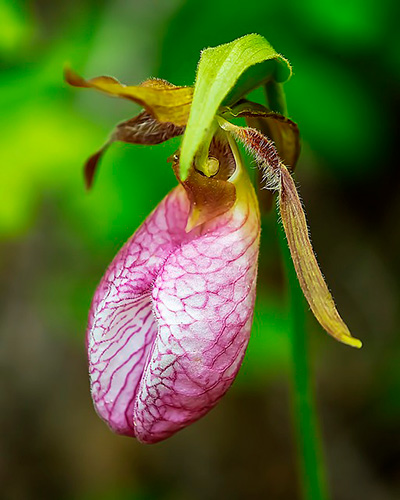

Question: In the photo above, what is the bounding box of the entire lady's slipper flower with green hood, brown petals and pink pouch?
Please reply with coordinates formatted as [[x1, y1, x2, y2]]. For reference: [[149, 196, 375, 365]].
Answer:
[[66, 35, 361, 443]]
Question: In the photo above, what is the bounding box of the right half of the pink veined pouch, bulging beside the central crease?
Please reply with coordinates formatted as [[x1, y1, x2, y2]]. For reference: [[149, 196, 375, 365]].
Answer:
[[134, 199, 259, 443]]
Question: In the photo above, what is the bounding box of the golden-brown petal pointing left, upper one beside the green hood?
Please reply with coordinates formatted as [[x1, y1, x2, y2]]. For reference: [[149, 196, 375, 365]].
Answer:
[[64, 68, 193, 126]]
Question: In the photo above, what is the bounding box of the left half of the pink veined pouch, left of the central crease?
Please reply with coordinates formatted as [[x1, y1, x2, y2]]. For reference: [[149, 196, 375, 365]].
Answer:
[[87, 187, 189, 435]]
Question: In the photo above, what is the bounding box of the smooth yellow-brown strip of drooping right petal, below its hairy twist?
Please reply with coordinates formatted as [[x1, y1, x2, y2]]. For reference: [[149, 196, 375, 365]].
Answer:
[[279, 165, 362, 347]]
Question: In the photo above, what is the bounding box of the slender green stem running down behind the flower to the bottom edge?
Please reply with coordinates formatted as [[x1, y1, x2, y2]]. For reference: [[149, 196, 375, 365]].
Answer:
[[265, 82, 329, 500]]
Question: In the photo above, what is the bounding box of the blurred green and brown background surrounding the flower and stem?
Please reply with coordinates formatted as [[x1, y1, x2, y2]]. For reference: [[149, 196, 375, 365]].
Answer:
[[0, 0, 400, 500]]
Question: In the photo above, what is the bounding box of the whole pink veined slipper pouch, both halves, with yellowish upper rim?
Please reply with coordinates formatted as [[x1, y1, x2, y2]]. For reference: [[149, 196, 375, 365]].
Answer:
[[87, 138, 260, 443]]
